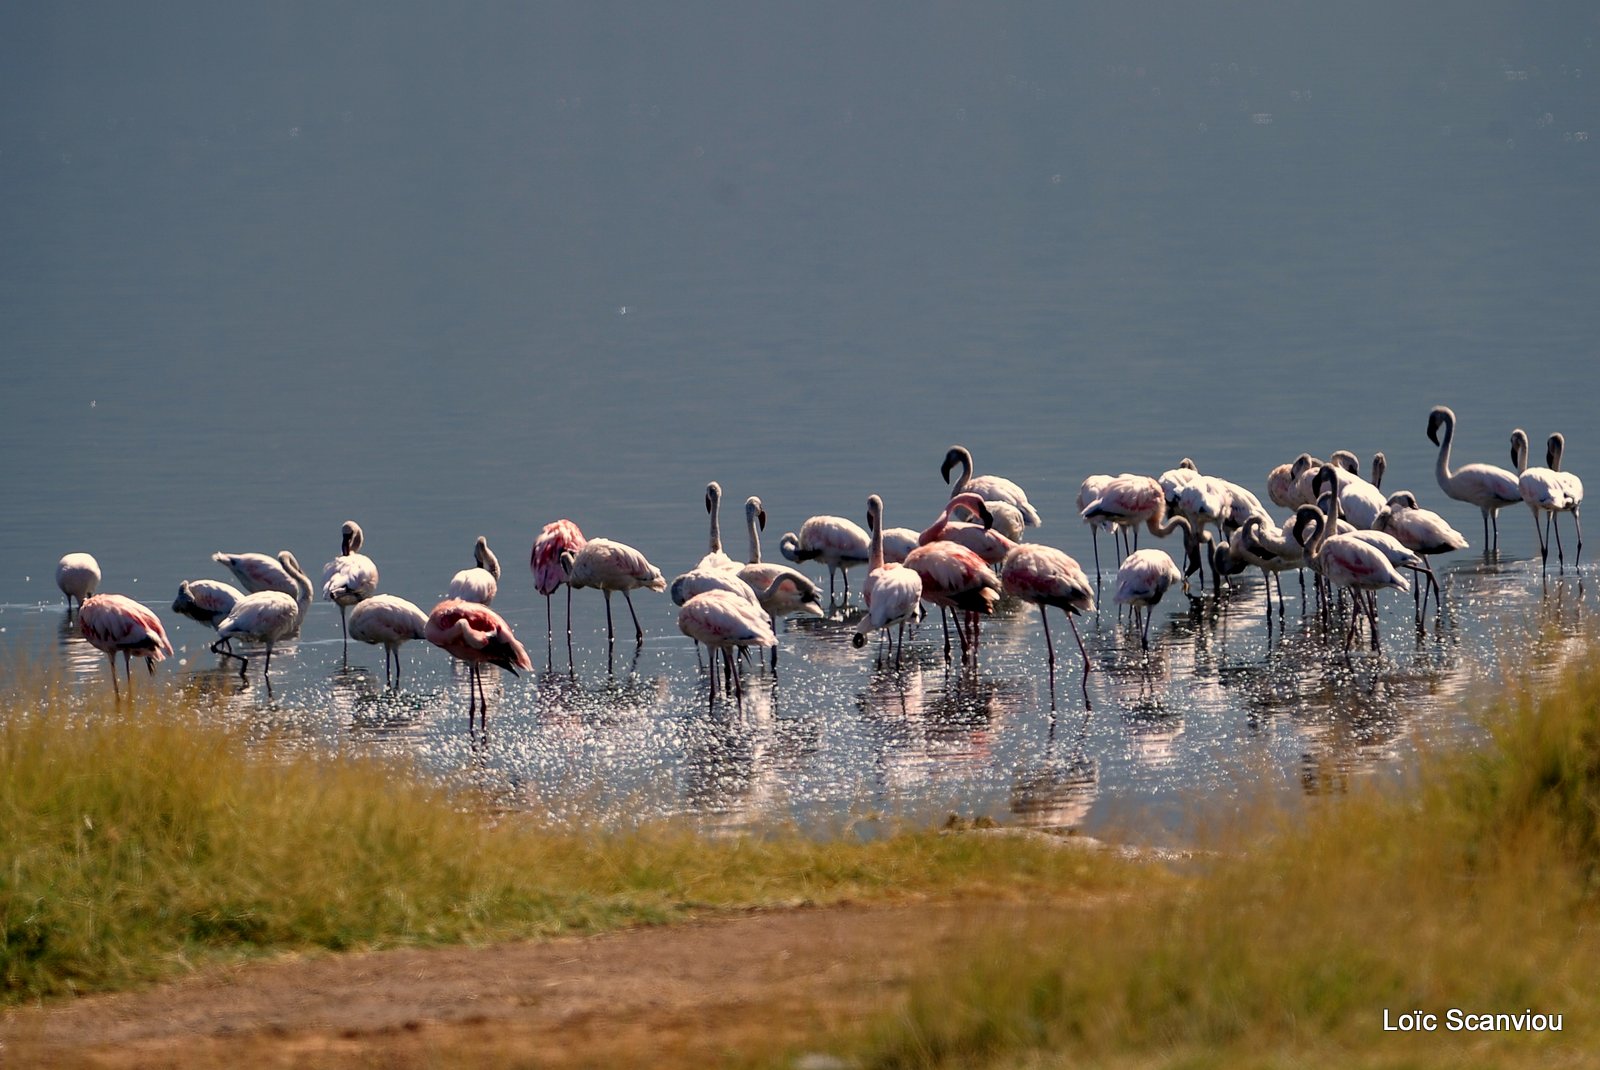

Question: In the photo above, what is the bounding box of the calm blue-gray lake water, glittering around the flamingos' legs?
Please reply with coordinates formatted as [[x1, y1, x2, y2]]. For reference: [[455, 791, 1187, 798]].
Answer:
[[0, 3, 1600, 838]]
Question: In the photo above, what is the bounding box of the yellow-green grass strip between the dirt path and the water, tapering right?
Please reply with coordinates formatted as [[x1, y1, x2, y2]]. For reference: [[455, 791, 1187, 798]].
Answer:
[[0, 670, 1142, 1003]]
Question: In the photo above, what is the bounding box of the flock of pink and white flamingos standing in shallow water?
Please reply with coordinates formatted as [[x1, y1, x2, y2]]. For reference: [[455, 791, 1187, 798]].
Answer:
[[56, 406, 1582, 726]]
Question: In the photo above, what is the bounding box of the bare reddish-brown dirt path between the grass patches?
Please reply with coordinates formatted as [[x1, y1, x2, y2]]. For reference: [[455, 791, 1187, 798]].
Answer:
[[0, 905, 1037, 1070]]
